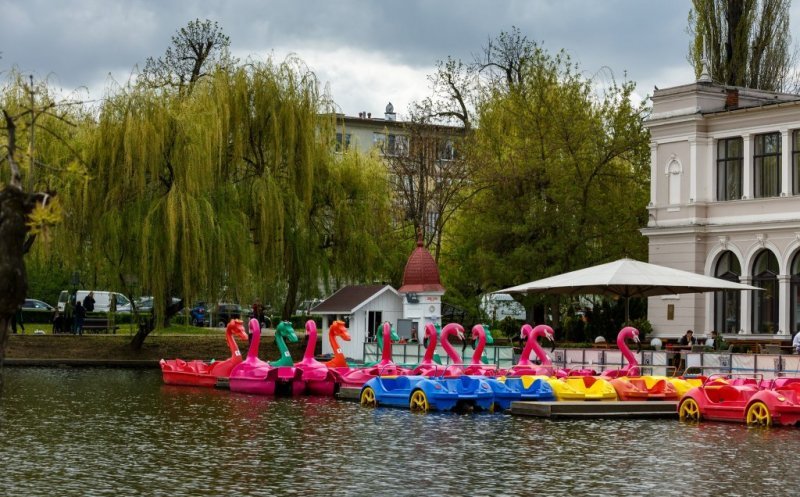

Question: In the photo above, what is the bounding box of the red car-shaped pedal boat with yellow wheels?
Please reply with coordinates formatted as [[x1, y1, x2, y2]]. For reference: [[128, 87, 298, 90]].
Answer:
[[678, 375, 800, 427]]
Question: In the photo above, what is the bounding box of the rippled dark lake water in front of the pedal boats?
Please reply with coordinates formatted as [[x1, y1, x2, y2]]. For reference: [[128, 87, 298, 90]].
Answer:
[[0, 367, 800, 497]]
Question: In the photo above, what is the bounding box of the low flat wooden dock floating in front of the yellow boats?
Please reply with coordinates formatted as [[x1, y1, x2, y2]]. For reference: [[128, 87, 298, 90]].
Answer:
[[511, 401, 678, 418]]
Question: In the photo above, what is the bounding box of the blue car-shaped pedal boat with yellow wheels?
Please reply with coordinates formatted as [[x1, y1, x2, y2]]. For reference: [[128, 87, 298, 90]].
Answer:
[[360, 375, 495, 412]]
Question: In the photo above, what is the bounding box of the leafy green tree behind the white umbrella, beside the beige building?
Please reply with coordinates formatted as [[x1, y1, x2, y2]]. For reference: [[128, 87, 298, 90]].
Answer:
[[445, 38, 649, 318]]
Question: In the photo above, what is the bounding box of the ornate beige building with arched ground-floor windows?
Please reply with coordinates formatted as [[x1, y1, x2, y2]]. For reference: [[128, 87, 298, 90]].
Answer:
[[642, 82, 800, 338]]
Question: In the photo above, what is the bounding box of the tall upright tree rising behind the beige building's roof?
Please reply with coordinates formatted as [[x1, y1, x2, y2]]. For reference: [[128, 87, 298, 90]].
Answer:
[[688, 0, 797, 91]]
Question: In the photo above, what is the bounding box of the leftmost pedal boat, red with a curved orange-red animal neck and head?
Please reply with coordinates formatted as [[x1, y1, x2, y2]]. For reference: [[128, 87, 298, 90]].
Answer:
[[159, 319, 247, 387]]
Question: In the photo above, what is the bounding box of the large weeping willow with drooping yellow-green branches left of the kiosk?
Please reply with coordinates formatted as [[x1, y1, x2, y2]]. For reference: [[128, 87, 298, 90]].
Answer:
[[89, 60, 392, 347]]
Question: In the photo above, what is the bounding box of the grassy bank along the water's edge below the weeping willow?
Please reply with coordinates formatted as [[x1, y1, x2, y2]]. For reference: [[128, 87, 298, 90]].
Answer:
[[6, 328, 310, 361]]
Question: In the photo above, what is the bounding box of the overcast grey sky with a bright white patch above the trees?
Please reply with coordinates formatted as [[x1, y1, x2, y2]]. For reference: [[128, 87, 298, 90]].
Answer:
[[6, 0, 800, 117]]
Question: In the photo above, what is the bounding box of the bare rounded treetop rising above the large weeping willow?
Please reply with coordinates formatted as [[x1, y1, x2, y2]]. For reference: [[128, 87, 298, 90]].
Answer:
[[140, 19, 236, 92]]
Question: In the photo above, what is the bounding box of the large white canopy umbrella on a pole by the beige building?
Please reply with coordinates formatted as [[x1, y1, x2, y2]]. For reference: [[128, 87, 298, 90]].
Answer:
[[493, 258, 761, 322]]
